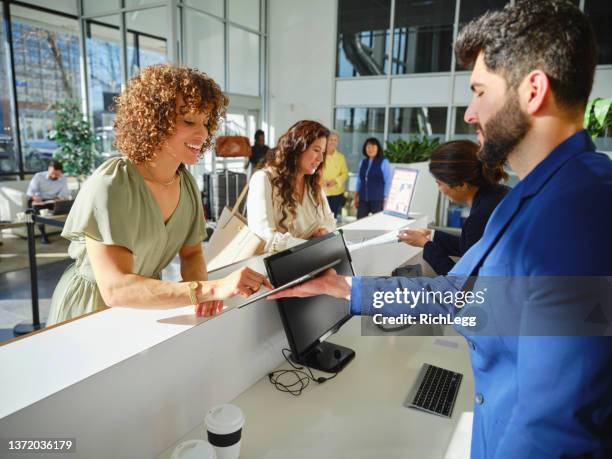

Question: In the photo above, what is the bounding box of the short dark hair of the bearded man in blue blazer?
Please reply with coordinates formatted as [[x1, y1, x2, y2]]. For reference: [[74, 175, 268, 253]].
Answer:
[[455, 0, 597, 109]]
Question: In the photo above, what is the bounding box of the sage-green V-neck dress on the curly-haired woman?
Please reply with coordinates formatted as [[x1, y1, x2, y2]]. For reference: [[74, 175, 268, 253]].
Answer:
[[47, 157, 206, 325]]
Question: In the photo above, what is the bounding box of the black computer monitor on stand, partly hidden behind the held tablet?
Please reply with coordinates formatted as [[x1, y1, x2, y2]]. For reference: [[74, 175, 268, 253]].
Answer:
[[264, 231, 355, 373]]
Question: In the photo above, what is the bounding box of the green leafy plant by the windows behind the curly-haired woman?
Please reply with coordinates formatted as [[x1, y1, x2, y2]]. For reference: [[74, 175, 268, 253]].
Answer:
[[48, 99, 98, 182]]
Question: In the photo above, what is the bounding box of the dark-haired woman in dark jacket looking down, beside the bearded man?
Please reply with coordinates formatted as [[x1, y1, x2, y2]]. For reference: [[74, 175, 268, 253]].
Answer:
[[399, 140, 510, 275]]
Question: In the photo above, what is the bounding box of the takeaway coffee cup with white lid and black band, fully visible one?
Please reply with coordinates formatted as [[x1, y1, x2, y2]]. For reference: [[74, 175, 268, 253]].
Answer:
[[204, 404, 244, 459]]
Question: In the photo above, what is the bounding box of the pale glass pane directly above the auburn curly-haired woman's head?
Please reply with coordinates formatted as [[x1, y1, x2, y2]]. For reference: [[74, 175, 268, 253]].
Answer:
[[183, 8, 225, 90]]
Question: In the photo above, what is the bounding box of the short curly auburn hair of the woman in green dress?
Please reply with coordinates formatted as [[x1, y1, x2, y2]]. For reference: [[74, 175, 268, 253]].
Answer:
[[113, 64, 228, 164]]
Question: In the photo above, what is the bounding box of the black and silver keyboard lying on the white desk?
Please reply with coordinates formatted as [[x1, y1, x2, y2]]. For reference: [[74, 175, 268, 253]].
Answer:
[[404, 363, 463, 418]]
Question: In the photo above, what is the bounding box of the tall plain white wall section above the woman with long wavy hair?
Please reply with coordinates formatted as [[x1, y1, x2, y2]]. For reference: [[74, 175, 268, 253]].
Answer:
[[268, 0, 337, 145]]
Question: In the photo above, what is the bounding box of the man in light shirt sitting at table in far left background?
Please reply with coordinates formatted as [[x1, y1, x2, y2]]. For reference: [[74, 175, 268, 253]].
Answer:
[[26, 161, 72, 244]]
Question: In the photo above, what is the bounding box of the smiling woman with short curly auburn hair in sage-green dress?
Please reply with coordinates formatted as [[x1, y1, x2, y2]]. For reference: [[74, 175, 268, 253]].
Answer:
[[47, 64, 270, 325]]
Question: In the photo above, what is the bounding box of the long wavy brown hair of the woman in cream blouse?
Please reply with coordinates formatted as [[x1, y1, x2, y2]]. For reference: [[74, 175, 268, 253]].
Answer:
[[265, 120, 329, 231]]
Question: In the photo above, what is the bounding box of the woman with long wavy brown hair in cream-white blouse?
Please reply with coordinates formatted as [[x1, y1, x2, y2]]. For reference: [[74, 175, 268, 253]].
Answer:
[[247, 120, 336, 252]]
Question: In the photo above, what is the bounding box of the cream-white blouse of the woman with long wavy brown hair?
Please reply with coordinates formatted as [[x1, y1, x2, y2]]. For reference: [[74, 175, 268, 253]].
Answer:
[[247, 169, 336, 252]]
